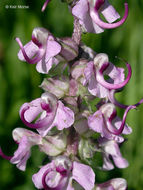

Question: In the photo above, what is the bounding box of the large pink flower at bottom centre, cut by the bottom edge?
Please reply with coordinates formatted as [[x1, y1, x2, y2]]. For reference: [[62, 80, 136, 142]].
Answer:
[[32, 156, 95, 190]]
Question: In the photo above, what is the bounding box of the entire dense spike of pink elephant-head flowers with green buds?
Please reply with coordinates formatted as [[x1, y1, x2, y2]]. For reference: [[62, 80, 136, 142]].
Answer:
[[0, 0, 143, 190]]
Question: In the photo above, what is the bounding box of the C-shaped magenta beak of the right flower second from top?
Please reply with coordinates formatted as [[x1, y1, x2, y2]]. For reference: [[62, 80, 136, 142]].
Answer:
[[95, 63, 132, 90]]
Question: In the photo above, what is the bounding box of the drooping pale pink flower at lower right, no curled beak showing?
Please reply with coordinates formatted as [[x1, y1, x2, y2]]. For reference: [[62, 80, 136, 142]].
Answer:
[[98, 138, 128, 170]]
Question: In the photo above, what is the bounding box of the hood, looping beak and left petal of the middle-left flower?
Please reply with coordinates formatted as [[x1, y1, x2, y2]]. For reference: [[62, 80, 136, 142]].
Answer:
[[20, 92, 57, 131]]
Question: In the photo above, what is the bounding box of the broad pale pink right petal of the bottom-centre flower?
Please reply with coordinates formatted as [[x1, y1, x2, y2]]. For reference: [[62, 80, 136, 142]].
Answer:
[[72, 161, 95, 190]]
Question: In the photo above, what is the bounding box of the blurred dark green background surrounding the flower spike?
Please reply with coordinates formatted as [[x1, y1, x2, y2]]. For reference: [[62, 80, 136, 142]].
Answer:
[[0, 0, 143, 190]]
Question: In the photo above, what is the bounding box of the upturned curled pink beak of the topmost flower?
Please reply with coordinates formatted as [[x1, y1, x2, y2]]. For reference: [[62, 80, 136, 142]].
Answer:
[[90, 0, 128, 29]]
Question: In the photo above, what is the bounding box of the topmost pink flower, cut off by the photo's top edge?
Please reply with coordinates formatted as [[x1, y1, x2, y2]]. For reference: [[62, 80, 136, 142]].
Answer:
[[72, 0, 128, 33]]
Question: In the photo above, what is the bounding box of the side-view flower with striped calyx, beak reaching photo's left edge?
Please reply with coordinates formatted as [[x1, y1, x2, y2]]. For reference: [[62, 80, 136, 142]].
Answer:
[[0, 128, 67, 171]]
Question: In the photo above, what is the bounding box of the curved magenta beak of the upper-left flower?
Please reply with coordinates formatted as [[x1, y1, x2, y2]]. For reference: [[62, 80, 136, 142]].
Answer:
[[16, 38, 45, 64]]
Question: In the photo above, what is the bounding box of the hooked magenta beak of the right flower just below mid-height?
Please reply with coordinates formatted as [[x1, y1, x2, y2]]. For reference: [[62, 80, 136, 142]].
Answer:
[[105, 106, 136, 135]]
